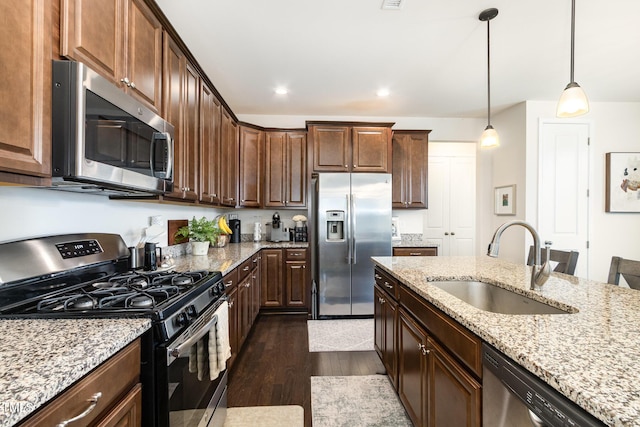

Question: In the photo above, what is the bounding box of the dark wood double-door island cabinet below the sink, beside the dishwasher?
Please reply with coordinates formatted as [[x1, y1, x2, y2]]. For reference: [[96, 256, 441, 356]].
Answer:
[[375, 270, 482, 427]]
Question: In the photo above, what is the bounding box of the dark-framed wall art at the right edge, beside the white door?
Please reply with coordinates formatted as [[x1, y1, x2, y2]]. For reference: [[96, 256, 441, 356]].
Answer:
[[605, 152, 640, 212]]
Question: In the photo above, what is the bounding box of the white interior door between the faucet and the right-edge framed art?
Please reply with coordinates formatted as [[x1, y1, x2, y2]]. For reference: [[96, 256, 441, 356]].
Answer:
[[538, 123, 589, 278]]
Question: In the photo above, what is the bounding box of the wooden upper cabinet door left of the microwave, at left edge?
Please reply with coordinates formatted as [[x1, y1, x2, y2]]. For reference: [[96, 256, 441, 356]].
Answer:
[[0, 0, 53, 177]]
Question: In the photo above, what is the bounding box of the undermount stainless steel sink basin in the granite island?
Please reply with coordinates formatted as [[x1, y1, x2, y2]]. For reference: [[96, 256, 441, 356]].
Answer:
[[429, 280, 569, 314]]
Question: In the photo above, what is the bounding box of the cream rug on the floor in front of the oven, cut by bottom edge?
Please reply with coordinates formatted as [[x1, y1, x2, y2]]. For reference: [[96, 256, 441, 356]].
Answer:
[[224, 405, 304, 427]]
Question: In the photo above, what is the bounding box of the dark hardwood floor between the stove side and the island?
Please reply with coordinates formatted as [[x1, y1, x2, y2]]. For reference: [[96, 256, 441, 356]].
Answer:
[[227, 314, 385, 427]]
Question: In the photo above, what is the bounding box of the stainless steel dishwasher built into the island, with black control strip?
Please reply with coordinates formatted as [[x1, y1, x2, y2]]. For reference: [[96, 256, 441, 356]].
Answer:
[[482, 344, 604, 427]]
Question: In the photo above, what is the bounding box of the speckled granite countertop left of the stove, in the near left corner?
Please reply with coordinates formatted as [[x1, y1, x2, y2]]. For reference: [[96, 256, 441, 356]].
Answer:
[[0, 319, 151, 427]]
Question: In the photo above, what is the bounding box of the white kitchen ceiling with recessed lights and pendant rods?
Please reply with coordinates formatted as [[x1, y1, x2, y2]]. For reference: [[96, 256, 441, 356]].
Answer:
[[156, 0, 640, 117]]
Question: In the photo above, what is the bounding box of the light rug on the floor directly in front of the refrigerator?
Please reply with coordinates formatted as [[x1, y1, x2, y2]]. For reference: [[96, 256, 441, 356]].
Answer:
[[307, 319, 374, 352]]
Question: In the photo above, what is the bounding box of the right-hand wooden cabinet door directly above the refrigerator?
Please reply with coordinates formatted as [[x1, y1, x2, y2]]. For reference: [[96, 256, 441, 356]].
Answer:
[[352, 127, 391, 172]]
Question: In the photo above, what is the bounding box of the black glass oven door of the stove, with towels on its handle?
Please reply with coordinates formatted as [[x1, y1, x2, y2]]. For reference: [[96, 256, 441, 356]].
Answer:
[[157, 302, 227, 427]]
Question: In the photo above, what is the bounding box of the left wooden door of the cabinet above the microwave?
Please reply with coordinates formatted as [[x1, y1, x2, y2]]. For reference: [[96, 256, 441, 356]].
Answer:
[[60, 0, 128, 86]]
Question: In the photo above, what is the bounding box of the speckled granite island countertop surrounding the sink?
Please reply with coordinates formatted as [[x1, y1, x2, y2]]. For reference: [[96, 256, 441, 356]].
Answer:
[[373, 256, 640, 426]]
